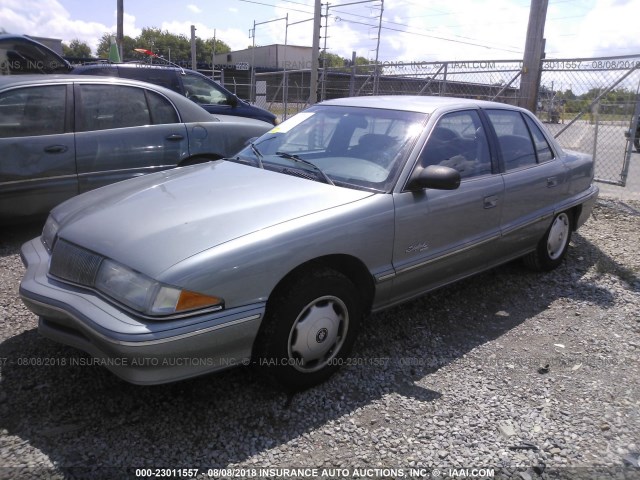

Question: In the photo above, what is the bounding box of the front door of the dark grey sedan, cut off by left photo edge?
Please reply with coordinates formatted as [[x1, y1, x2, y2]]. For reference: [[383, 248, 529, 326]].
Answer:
[[0, 84, 78, 220]]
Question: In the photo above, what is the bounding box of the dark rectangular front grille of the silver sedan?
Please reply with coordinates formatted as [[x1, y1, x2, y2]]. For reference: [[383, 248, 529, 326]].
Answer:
[[49, 239, 102, 287]]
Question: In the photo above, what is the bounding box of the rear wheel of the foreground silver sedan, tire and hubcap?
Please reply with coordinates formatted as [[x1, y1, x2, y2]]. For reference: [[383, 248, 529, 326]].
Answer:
[[524, 212, 572, 272]]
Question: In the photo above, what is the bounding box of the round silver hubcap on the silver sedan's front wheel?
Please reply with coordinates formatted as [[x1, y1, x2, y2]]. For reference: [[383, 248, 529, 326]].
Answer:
[[288, 296, 349, 373]]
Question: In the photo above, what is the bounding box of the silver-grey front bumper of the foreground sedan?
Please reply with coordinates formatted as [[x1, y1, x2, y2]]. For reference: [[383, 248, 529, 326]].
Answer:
[[20, 238, 265, 385]]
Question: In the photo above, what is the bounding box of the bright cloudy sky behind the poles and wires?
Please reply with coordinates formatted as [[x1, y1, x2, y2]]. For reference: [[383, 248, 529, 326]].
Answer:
[[0, 0, 640, 62]]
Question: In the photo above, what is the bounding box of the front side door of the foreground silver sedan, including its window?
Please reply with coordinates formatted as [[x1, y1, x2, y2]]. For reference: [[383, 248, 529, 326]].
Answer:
[[393, 110, 504, 298]]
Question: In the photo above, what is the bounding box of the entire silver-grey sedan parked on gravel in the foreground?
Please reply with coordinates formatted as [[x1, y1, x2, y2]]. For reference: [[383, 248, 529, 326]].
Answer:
[[20, 96, 598, 389]]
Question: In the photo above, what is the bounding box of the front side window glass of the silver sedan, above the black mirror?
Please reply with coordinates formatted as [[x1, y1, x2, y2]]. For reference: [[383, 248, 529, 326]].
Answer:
[[419, 110, 491, 180]]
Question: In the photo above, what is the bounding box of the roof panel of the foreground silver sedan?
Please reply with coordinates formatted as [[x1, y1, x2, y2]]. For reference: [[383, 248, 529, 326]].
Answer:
[[318, 95, 522, 114]]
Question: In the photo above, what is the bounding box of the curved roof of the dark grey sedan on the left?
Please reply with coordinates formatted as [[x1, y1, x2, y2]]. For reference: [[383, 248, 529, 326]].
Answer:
[[0, 74, 217, 122]]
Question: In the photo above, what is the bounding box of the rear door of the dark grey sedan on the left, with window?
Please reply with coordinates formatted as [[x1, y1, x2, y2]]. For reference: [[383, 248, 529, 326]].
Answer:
[[75, 83, 189, 192]]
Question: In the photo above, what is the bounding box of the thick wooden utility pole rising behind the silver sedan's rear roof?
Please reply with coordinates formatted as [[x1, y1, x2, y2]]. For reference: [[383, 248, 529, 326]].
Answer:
[[518, 0, 549, 113]]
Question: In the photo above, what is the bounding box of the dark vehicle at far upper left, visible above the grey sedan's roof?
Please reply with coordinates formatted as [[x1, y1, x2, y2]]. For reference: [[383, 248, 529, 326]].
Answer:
[[0, 33, 71, 75]]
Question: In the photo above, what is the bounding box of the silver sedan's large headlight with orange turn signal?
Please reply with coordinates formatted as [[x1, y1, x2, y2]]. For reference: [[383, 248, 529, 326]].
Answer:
[[95, 259, 223, 317]]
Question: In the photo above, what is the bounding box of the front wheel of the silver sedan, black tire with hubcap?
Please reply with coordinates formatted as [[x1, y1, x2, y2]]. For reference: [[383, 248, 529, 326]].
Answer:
[[253, 268, 362, 391]]
